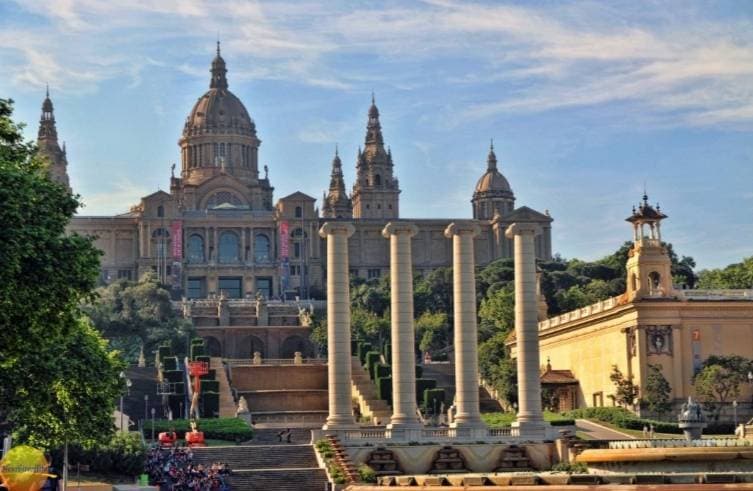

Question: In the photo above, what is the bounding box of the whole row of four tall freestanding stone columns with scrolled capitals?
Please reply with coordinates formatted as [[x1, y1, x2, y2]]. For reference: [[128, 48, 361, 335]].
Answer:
[[319, 221, 544, 438]]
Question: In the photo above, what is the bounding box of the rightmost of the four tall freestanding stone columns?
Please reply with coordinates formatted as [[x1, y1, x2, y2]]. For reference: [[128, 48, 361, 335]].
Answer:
[[505, 223, 546, 439]]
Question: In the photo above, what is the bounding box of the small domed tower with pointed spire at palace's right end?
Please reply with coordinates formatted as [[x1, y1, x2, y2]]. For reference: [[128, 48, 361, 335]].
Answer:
[[471, 142, 515, 220]]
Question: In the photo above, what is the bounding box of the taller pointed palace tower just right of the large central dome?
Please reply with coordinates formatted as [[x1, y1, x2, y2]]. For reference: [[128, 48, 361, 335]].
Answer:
[[352, 95, 400, 219]]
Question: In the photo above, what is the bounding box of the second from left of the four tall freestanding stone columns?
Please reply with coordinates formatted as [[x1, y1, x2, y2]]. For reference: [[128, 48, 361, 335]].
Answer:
[[382, 222, 421, 429]]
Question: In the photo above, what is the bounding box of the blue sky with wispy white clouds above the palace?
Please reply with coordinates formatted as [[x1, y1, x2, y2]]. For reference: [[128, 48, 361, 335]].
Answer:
[[0, 0, 753, 269]]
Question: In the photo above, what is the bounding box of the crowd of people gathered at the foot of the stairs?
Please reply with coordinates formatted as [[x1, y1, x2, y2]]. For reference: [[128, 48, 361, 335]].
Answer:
[[146, 447, 230, 491]]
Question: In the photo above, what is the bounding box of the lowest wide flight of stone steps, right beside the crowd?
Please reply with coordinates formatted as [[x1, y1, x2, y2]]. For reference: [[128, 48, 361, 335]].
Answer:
[[194, 444, 328, 491]]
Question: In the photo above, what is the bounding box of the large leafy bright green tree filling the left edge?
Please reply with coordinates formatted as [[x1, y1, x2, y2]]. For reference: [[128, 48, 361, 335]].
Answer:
[[0, 99, 121, 448]]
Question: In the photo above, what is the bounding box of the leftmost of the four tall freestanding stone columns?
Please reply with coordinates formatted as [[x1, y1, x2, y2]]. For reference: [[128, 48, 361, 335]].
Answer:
[[319, 222, 356, 430]]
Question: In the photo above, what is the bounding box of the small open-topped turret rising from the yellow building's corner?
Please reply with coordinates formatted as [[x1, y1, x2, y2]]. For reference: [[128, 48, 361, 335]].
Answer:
[[625, 194, 675, 302]]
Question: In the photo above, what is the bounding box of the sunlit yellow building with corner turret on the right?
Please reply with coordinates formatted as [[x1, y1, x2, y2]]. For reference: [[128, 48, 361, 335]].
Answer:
[[508, 196, 753, 412]]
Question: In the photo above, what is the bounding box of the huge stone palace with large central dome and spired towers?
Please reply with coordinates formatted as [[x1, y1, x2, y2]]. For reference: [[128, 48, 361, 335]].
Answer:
[[38, 43, 552, 300]]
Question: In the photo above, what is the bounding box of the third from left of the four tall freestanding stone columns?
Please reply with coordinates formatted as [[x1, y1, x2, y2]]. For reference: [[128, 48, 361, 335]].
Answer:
[[444, 222, 485, 429]]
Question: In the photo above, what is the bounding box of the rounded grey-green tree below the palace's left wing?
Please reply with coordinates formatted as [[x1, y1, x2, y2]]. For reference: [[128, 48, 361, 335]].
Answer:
[[84, 272, 194, 361]]
